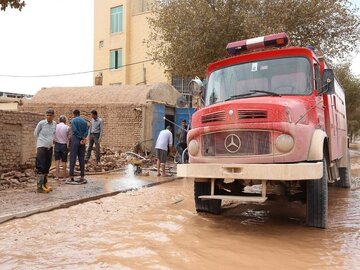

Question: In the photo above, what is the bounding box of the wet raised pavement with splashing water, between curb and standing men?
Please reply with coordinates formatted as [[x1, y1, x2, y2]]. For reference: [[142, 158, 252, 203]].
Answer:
[[0, 166, 175, 223]]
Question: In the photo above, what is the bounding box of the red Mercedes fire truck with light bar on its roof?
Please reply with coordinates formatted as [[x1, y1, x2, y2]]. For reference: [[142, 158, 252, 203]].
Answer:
[[177, 33, 350, 228]]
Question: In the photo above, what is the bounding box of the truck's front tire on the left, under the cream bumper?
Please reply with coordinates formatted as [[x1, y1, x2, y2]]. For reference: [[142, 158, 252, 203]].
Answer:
[[194, 182, 221, 215]]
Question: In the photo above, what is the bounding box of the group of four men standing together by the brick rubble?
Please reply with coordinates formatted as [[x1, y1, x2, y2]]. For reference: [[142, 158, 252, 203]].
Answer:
[[34, 109, 104, 193]]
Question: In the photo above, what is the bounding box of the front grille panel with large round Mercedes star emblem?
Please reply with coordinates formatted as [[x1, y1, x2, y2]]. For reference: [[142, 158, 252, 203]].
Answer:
[[202, 130, 272, 156]]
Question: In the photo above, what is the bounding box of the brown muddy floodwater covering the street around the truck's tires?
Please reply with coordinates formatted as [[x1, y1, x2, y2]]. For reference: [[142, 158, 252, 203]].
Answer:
[[0, 163, 360, 270]]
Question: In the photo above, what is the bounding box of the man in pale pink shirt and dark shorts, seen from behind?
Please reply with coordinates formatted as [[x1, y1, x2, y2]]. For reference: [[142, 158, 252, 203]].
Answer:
[[54, 115, 70, 180]]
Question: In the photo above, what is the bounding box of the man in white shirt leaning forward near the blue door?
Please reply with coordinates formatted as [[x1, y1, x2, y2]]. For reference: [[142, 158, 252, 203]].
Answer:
[[155, 126, 173, 176]]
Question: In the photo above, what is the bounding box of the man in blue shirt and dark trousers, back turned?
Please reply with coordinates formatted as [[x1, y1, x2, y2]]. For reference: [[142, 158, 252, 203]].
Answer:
[[67, 109, 88, 184]]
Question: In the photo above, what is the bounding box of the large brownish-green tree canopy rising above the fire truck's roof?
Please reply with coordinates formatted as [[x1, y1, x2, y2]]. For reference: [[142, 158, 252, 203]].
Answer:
[[146, 0, 360, 76]]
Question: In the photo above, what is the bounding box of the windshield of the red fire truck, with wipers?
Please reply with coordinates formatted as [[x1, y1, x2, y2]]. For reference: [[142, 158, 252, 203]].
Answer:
[[205, 57, 313, 105]]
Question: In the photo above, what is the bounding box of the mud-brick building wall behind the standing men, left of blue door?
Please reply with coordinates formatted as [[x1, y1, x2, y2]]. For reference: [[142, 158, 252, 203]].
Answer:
[[22, 102, 144, 151]]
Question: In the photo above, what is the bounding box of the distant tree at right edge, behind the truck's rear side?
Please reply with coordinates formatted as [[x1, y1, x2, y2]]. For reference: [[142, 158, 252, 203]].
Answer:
[[335, 63, 360, 140]]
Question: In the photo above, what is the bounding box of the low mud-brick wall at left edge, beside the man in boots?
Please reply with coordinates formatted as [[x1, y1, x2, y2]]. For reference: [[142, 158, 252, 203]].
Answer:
[[0, 110, 44, 172]]
